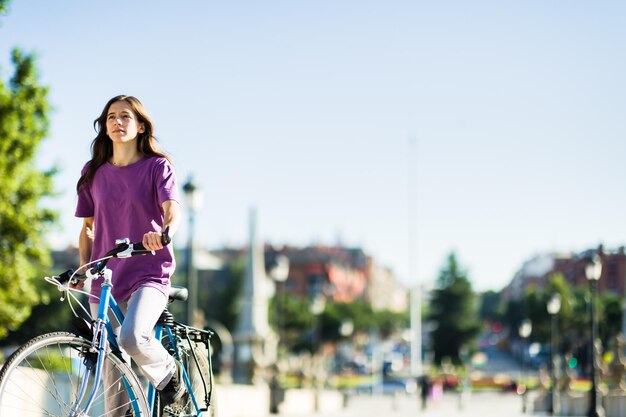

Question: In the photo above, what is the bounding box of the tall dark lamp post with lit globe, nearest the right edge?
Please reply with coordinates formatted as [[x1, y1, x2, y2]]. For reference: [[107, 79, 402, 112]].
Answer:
[[585, 254, 604, 417]]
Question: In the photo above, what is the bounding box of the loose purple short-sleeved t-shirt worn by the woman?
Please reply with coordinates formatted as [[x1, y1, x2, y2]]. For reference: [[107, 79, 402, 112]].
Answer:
[[75, 157, 179, 302]]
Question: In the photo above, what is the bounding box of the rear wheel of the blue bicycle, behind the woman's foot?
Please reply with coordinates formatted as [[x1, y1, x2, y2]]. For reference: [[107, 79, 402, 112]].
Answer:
[[157, 340, 217, 417]]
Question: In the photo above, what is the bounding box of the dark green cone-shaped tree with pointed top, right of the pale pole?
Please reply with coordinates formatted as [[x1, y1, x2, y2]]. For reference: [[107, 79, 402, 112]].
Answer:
[[428, 253, 480, 365]]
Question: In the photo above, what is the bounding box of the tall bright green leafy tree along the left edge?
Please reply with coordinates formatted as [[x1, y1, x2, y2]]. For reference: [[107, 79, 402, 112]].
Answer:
[[0, 44, 56, 338]]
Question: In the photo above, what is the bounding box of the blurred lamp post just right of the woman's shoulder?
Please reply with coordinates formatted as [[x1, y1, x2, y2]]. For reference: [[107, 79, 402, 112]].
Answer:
[[183, 176, 202, 326]]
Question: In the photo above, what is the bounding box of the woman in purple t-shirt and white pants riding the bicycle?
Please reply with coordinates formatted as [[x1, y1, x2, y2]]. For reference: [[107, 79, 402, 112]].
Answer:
[[76, 95, 181, 410]]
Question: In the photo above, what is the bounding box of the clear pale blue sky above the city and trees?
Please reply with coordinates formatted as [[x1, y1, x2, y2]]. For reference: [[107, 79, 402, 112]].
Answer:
[[0, 0, 626, 290]]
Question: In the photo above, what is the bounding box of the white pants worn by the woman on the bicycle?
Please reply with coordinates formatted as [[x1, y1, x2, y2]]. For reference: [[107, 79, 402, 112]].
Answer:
[[90, 287, 176, 416]]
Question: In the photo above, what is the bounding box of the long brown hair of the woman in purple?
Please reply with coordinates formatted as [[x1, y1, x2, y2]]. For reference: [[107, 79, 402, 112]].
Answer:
[[76, 95, 169, 191]]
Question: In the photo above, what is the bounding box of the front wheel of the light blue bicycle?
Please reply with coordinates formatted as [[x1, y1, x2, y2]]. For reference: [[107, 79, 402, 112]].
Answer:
[[0, 332, 149, 417]]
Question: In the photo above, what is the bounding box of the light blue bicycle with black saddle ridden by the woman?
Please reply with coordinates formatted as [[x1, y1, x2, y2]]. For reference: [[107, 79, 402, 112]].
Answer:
[[0, 229, 217, 417]]
